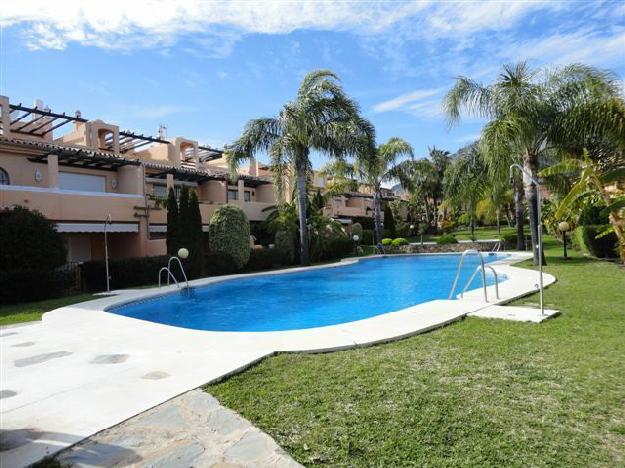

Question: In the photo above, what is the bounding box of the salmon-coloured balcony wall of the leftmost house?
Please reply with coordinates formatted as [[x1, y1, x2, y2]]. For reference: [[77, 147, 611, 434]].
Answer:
[[0, 185, 144, 223]]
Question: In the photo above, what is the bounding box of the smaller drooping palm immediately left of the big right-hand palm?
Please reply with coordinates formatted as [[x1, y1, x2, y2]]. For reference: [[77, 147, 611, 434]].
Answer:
[[445, 143, 488, 239]]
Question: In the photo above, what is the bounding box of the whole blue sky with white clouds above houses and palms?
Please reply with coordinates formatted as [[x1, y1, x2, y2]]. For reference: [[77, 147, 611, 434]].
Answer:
[[0, 0, 625, 166]]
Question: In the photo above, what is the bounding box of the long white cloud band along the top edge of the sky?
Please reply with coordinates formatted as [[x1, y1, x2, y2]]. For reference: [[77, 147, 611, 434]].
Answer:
[[0, 0, 560, 51]]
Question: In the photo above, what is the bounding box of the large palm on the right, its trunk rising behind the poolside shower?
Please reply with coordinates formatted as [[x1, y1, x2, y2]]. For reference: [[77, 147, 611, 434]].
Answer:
[[444, 62, 618, 263]]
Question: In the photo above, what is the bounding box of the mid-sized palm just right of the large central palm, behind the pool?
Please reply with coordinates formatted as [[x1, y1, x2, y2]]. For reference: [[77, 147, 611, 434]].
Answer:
[[325, 137, 414, 242]]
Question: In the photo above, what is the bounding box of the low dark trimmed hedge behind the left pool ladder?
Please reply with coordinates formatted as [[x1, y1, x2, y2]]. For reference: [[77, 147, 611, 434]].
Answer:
[[82, 255, 171, 292]]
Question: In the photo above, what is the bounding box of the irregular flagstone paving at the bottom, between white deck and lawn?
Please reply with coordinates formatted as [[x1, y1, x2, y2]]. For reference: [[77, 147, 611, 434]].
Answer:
[[55, 390, 301, 468]]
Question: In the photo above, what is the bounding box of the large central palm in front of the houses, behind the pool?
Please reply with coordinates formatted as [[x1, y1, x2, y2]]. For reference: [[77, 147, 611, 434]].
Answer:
[[226, 70, 374, 265]]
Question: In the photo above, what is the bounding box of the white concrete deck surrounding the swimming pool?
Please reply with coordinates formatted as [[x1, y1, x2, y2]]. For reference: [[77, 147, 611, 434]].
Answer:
[[0, 253, 555, 467]]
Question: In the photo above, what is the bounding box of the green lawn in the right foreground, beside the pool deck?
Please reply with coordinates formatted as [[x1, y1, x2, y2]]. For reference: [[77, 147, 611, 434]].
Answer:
[[206, 240, 625, 466]]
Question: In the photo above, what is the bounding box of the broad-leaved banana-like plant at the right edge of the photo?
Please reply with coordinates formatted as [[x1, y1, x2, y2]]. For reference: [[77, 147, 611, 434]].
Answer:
[[540, 150, 625, 261]]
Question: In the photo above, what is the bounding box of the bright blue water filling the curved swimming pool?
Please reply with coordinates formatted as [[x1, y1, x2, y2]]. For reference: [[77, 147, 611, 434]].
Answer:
[[108, 255, 505, 331]]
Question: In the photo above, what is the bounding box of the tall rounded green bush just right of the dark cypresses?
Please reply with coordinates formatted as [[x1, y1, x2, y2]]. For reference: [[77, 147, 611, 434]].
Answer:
[[208, 205, 250, 269]]
